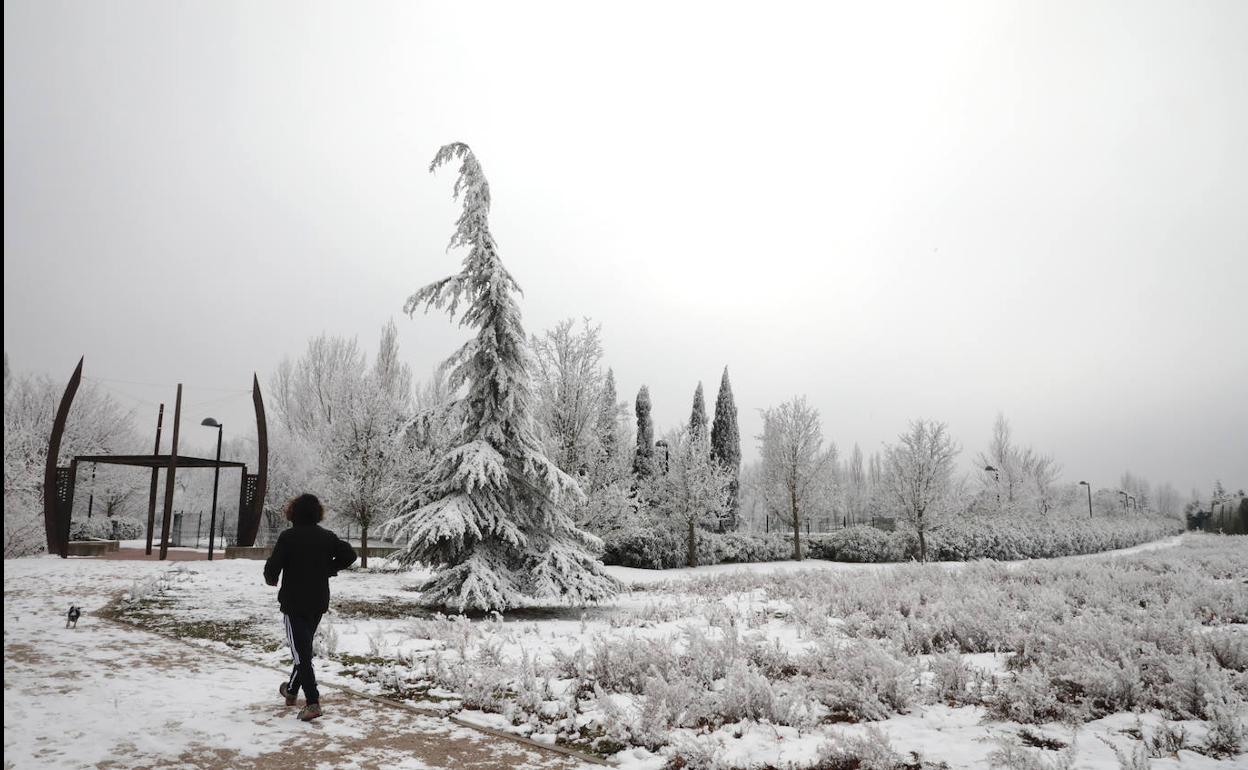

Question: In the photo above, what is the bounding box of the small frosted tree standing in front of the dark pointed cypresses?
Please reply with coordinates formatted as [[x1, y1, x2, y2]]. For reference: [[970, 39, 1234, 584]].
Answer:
[[641, 429, 730, 567]]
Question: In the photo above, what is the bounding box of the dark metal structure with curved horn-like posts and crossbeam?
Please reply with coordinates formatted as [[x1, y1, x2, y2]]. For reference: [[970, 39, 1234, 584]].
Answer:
[[44, 358, 268, 559]]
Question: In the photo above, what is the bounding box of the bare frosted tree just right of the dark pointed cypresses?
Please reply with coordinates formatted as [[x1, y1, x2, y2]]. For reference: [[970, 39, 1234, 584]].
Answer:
[[758, 396, 836, 562]]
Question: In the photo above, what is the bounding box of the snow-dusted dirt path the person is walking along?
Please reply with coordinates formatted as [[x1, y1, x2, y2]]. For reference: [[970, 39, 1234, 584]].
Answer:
[[4, 558, 594, 770]]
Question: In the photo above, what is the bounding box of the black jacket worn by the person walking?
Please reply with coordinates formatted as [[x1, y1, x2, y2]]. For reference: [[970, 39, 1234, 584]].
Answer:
[[265, 524, 356, 616]]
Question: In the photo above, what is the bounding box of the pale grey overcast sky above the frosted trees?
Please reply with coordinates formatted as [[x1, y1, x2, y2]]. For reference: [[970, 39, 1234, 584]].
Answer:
[[4, 0, 1248, 494]]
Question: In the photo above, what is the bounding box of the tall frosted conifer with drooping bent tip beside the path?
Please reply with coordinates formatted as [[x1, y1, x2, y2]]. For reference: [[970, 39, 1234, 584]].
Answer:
[[388, 142, 619, 612]]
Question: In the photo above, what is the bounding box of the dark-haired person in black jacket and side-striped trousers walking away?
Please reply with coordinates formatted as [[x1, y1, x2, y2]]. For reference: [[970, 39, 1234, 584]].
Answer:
[[265, 494, 356, 721]]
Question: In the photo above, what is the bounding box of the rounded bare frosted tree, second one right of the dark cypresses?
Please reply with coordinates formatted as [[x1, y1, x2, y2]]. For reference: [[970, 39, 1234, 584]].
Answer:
[[885, 419, 958, 562]]
